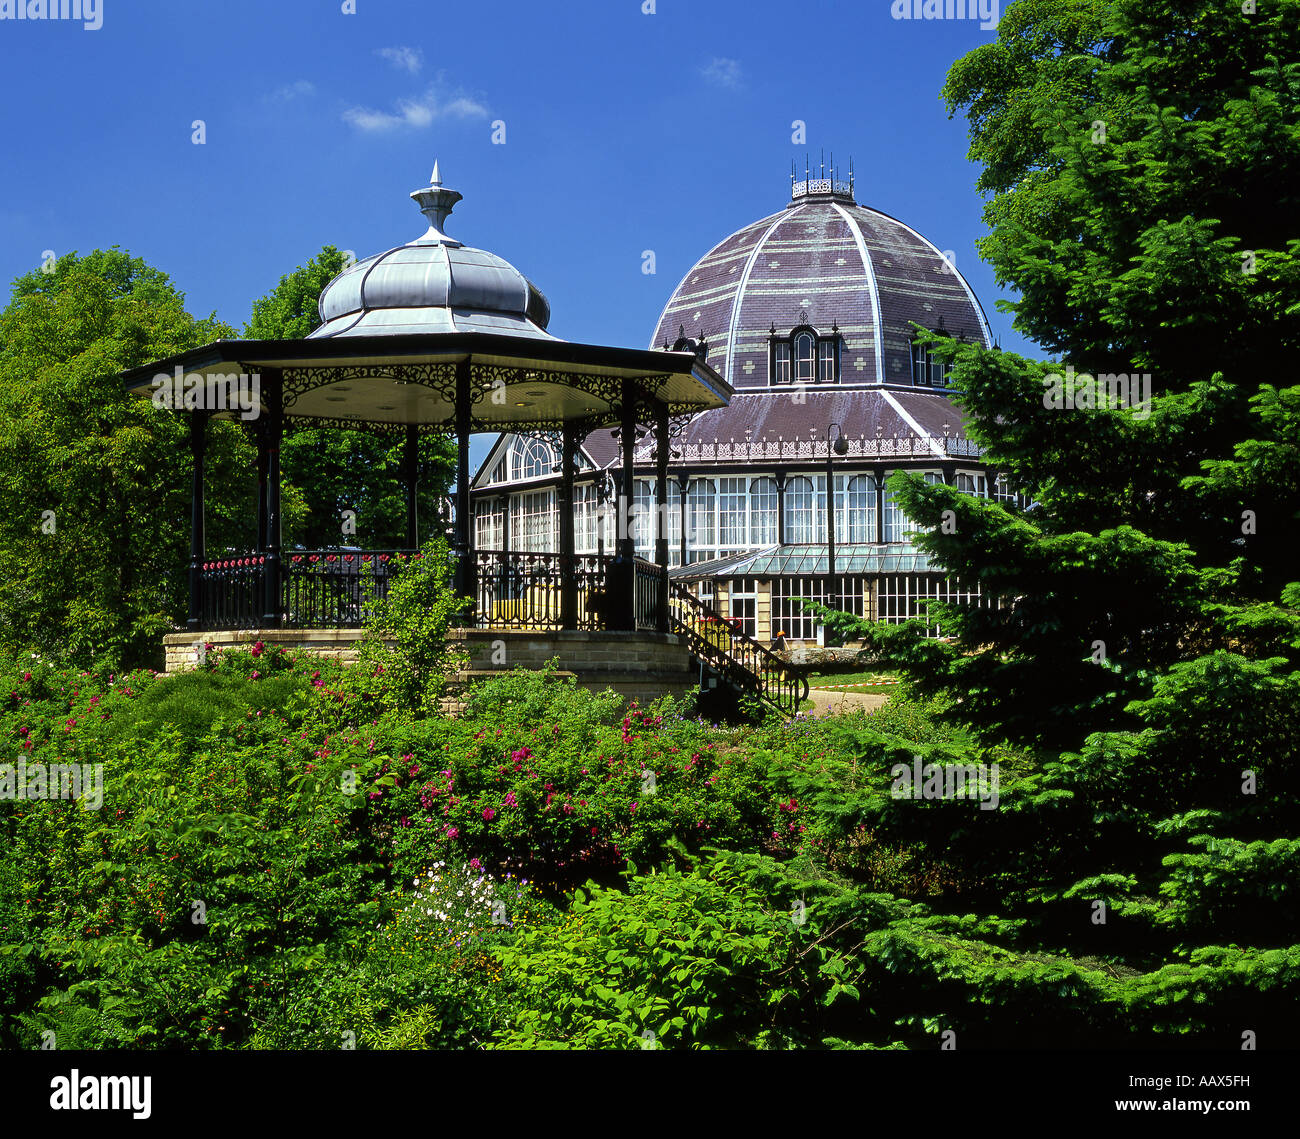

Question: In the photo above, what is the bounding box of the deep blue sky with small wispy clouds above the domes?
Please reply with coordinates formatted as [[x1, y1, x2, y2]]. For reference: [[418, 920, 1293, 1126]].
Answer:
[[0, 0, 1043, 468]]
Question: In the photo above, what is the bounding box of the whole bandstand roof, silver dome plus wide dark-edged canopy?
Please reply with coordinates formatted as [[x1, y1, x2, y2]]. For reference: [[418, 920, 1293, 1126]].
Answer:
[[121, 164, 731, 432]]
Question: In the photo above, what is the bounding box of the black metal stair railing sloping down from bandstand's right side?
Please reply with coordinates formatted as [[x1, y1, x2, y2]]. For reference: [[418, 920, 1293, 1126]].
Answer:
[[668, 581, 809, 715]]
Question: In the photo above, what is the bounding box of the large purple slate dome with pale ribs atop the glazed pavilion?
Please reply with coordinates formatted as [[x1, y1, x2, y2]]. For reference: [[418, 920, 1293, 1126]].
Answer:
[[651, 178, 992, 389]]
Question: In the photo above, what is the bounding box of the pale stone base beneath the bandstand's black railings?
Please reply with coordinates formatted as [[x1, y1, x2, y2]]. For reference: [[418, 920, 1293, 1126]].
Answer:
[[163, 629, 699, 714]]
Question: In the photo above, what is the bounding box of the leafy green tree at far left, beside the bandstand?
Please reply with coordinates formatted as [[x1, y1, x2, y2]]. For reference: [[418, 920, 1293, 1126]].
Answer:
[[0, 247, 255, 664]]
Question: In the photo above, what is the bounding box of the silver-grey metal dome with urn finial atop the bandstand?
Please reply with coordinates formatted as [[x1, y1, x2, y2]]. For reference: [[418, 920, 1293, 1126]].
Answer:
[[311, 164, 555, 339]]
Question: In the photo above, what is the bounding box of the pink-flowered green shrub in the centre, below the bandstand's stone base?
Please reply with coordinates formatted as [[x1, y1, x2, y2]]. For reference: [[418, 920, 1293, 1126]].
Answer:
[[374, 670, 798, 889]]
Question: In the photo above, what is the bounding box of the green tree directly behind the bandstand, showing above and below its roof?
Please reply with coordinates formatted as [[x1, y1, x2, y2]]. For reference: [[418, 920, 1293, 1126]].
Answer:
[[244, 246, 455, 549]]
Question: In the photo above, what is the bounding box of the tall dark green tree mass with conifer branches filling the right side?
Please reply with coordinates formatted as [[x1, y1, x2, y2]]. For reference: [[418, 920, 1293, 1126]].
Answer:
[[795, 0, 1300, 1041]]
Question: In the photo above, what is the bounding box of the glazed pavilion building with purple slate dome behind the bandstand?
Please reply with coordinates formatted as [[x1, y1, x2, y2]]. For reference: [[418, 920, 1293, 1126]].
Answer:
[[471, 164, 1014, 644]]
